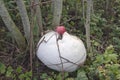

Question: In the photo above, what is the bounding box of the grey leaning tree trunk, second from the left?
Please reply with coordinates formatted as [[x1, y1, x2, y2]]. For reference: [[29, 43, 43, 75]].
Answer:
[[16, 0, 30, 42]]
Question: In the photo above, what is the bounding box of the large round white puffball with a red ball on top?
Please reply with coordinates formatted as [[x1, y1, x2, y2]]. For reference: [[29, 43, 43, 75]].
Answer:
[[37, 31, 86, 72]]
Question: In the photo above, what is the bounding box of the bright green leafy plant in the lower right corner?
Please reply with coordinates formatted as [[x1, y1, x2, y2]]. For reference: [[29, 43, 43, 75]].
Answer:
[[88, 45, 120, 80]]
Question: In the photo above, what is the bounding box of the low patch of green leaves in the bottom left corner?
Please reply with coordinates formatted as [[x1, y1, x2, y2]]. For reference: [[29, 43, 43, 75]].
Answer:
[[0, 63, 32, 80]]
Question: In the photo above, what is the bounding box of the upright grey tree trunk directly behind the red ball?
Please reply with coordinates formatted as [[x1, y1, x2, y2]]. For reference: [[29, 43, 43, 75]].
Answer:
[[52, 0, 63, 27]]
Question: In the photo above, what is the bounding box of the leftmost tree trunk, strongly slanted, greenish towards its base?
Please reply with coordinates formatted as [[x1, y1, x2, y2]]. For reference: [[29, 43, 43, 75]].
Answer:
[[0, 0, 26, 50]]
